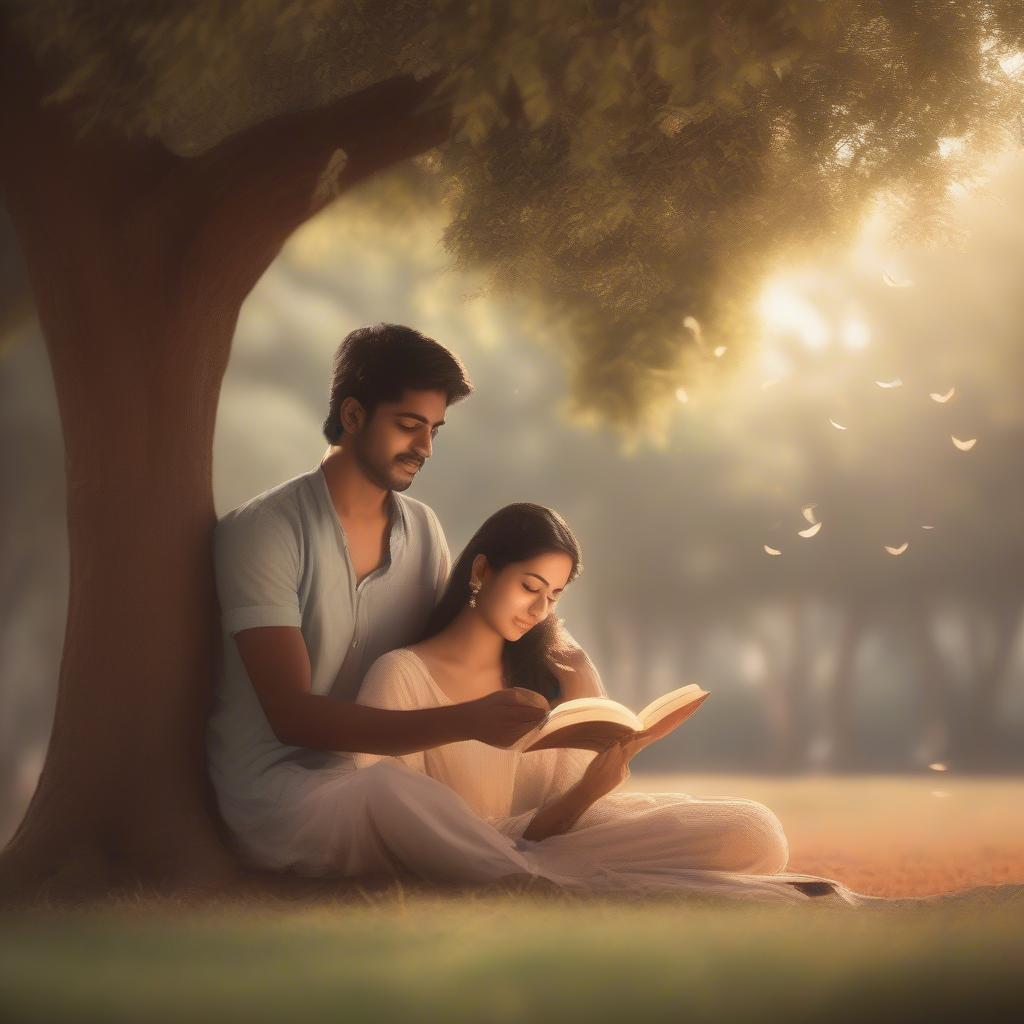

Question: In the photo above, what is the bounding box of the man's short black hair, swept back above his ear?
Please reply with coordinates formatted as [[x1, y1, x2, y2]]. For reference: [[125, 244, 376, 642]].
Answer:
[[324, 324, 473, 444]]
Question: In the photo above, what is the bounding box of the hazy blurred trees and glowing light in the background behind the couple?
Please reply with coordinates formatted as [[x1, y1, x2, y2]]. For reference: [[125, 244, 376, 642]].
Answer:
[[0, 146, 1024, 839]]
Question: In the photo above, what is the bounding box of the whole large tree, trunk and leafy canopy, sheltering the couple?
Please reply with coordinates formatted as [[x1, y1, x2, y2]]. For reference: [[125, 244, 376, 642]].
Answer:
[[0, 0, 1024, 893]]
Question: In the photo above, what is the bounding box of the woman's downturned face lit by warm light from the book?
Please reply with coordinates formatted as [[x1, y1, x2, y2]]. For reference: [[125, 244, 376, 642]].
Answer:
[[475, 551, 572, 640]]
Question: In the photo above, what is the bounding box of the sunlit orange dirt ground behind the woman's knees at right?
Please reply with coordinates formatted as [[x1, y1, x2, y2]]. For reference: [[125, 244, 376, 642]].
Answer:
[[625, 771, 1024, 896]]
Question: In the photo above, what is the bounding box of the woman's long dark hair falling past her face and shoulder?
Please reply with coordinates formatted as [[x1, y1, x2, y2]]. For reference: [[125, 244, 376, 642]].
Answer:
[[422, 502, 583, 700]]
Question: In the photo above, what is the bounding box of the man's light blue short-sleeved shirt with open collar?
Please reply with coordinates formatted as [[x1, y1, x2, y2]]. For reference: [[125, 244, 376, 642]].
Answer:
[[207, 466, 451, 806]]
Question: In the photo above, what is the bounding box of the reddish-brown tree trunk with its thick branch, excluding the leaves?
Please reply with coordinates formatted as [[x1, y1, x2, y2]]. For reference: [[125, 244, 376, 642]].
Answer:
[[0, 25, 447, 900]]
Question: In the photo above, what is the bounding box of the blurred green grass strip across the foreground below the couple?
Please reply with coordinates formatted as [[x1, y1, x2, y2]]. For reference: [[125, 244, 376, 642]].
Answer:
[[0, 886, 1024, 1024]]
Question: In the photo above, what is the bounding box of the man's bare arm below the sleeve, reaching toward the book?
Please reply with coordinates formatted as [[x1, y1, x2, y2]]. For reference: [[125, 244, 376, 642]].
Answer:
[[234, 626, 548, 755]]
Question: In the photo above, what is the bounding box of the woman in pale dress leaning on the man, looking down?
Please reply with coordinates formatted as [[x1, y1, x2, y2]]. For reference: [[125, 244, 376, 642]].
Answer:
[[352, 504, 888, 905]]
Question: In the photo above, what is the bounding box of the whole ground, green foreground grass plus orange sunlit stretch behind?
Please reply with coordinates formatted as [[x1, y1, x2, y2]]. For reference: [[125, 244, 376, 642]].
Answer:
[[0, 776, 1024, 1024]]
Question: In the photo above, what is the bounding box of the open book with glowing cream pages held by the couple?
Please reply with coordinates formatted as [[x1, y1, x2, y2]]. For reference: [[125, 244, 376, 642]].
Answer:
[[515, 683, 710, 752]]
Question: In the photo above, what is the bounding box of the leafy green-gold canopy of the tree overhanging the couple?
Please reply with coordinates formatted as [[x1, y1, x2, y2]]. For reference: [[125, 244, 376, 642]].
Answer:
[[6, 0, 1024, 426]]
